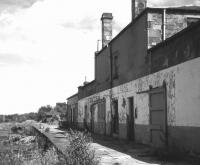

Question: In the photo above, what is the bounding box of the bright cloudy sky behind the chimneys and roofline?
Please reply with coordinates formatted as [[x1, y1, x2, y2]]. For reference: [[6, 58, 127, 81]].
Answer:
[[0, 0, 200, 114]]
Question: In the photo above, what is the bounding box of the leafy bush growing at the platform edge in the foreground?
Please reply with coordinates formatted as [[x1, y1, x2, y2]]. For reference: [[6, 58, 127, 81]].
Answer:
[[65, 130, 98, 165]]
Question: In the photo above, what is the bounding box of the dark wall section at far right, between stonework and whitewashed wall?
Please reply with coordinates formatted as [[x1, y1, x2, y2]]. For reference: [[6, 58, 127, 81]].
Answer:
[[149, 21, 200, 72]]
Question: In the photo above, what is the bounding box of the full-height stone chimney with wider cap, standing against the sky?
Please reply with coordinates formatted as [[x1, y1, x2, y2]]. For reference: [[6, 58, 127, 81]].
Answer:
[[101, 13, 113, 48]]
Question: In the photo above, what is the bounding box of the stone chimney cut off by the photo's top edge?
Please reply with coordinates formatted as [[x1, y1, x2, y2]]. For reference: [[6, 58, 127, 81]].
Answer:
[[131, 0, 147, 21]]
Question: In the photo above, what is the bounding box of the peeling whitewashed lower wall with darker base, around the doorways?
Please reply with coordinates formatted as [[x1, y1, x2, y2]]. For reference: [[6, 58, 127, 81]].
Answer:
[[79, 58, 200, 152]]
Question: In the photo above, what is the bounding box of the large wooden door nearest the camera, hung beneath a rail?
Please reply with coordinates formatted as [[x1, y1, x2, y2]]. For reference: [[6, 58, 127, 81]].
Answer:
[[149, 88, 167, 148]]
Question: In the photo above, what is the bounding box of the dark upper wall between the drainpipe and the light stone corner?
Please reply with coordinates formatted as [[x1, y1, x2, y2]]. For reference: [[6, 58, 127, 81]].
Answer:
[[111, 13, 148, 86]]
